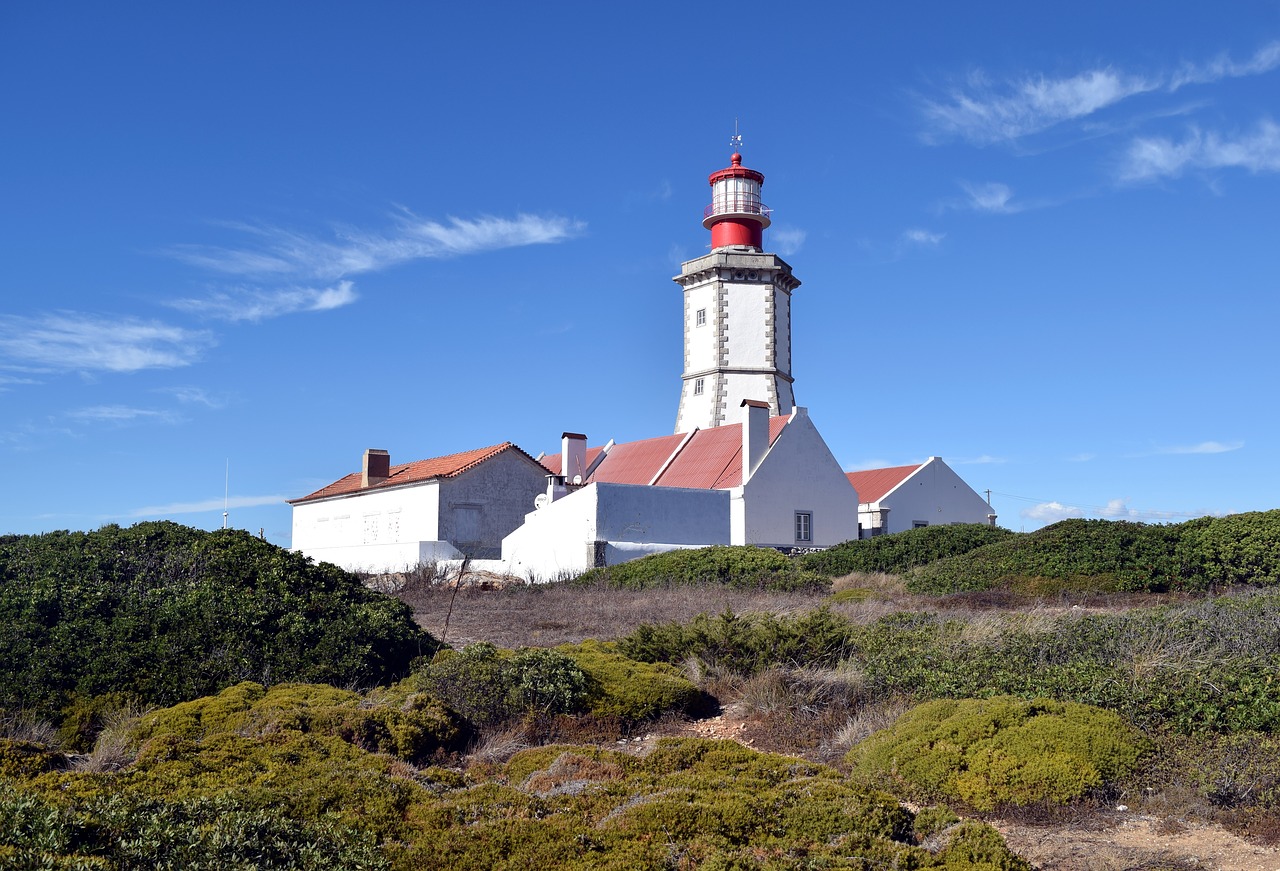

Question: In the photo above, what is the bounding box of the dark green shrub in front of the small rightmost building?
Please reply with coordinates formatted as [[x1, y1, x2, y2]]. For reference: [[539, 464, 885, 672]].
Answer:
[[800, 524, 1015, 576]]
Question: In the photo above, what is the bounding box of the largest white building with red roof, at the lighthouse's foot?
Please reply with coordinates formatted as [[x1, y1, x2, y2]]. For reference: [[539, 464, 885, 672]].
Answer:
[[502, 400, 858, 579]]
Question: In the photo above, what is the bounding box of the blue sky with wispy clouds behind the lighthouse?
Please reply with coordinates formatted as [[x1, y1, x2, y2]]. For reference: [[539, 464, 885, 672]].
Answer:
[[0, 0, 1280, 544]]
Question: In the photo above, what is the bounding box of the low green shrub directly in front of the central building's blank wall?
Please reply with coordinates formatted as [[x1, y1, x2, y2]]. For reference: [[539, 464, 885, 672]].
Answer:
[[571, 546, 831, 592]]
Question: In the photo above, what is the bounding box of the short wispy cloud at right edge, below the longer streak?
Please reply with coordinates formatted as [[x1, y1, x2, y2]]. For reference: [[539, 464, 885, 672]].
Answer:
[[1119, 120, 1280, 182]]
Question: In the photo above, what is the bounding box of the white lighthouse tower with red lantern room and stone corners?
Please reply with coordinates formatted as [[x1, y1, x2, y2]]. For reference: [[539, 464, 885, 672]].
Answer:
[[673, 150, 800, 433]]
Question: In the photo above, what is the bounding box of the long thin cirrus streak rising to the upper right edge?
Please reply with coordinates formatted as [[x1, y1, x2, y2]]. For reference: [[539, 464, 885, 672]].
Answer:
[[920, 41, 1280, 145]]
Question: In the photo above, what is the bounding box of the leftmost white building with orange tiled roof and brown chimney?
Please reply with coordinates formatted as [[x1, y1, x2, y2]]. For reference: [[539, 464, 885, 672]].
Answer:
[[289, 442, 547, 571]]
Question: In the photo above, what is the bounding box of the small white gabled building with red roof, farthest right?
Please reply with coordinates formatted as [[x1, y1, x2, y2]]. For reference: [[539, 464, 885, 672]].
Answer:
[[847, 457, 996, 538]]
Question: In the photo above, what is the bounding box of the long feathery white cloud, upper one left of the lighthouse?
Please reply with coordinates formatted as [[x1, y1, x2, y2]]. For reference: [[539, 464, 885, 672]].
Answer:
[[170, 209, 586, 281]]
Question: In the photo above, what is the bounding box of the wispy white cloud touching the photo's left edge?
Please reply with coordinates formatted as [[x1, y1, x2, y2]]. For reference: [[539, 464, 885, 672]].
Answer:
[[0, 311, 214, 373]]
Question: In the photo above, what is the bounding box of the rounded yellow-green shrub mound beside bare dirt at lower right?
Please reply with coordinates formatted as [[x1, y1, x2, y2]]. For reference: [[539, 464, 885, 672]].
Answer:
[[847, 697, 1148, 811]]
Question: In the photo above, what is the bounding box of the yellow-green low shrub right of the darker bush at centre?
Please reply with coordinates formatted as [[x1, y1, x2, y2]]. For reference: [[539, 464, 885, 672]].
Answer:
[[556, 640, 704, 728]]
